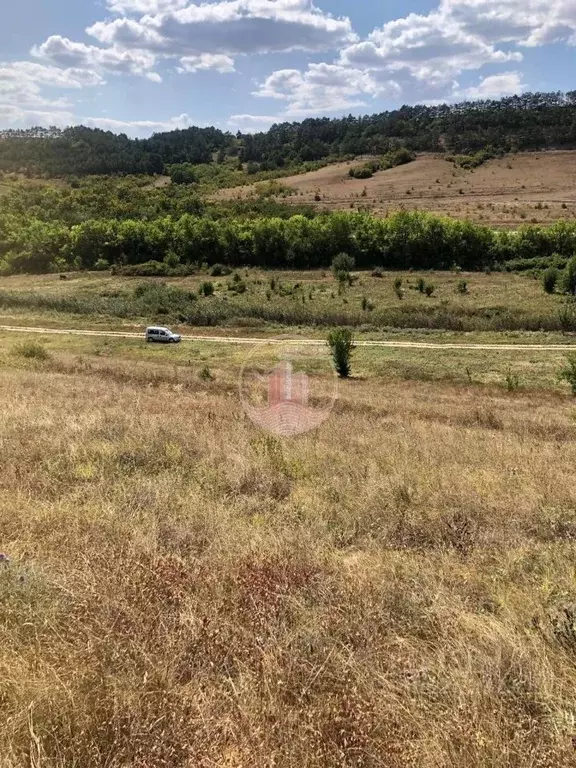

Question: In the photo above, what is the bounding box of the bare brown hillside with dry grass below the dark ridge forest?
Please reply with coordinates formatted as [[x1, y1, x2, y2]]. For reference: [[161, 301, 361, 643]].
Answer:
[[220, 151, 576, 228]]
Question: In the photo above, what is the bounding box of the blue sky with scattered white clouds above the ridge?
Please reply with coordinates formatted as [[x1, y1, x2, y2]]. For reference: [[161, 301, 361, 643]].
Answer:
[[0, 0, 576, 137]]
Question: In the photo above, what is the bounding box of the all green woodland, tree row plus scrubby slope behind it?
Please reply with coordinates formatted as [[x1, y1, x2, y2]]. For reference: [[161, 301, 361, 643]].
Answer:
[[0, 178, 576, 274]]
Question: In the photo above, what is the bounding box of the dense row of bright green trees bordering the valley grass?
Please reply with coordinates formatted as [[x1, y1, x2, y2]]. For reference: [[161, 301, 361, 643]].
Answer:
[[0, 212, 576, 274]]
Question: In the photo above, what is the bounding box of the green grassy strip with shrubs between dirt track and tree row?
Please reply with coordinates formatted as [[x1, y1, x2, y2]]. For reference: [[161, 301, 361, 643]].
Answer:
[[0, 269, 572, 332]]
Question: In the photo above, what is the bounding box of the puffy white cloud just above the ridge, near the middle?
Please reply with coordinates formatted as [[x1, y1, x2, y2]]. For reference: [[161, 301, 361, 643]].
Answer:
[[254, 64, 401, 117]]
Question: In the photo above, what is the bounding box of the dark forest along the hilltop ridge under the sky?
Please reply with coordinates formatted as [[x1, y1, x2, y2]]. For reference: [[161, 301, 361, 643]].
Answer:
[[0, 91, 576, 177]]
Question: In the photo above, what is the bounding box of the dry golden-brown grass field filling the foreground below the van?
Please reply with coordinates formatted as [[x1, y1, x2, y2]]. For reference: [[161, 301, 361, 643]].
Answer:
[[0, 339, 576, 768]]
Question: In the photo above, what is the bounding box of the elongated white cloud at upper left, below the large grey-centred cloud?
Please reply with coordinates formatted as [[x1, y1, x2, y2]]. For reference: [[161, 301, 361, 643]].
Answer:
[[32, 35, 159, 82]]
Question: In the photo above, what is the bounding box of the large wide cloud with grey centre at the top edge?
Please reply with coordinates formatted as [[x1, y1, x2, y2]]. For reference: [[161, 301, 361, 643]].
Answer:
[[86, 0, 356, 56]]
